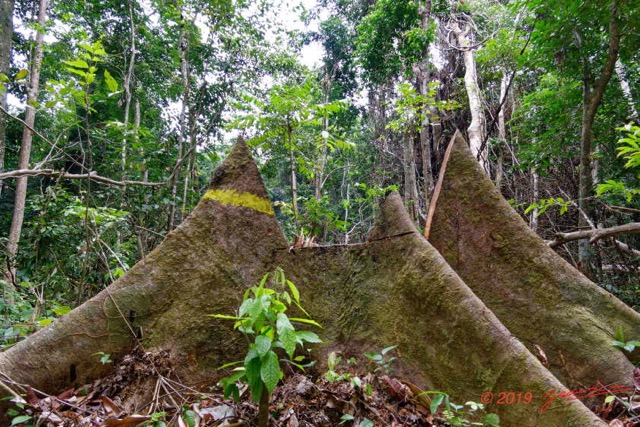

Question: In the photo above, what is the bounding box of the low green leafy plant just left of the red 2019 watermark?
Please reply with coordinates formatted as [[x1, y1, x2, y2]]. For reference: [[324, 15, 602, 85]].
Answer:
[[418, 391, 500, 427]]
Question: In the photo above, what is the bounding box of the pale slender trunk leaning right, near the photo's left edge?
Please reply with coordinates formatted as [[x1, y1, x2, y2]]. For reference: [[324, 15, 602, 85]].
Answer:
[[7, 0, 49, 283]]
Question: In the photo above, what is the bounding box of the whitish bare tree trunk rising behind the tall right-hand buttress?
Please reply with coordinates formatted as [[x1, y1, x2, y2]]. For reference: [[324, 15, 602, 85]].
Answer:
[[452, 18, 489, 174]]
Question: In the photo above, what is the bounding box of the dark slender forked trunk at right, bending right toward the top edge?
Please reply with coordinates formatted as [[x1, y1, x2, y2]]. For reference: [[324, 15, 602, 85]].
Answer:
[[578, 1, 622, 272]]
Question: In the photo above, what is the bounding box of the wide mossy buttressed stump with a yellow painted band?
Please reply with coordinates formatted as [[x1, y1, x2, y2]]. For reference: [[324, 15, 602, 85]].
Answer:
[[0, 142, 605, 427]]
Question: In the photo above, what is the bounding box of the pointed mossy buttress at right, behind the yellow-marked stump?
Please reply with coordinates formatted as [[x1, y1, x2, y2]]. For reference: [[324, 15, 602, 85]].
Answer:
[[426, 133, 640, 388]]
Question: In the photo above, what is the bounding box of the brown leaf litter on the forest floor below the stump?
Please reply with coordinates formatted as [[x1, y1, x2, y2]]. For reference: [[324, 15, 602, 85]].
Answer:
[[6, 351, 640, 427]]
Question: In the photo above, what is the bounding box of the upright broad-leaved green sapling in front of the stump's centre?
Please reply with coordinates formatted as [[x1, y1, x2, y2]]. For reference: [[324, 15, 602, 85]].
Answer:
[[211, 268, 321, 427]]
